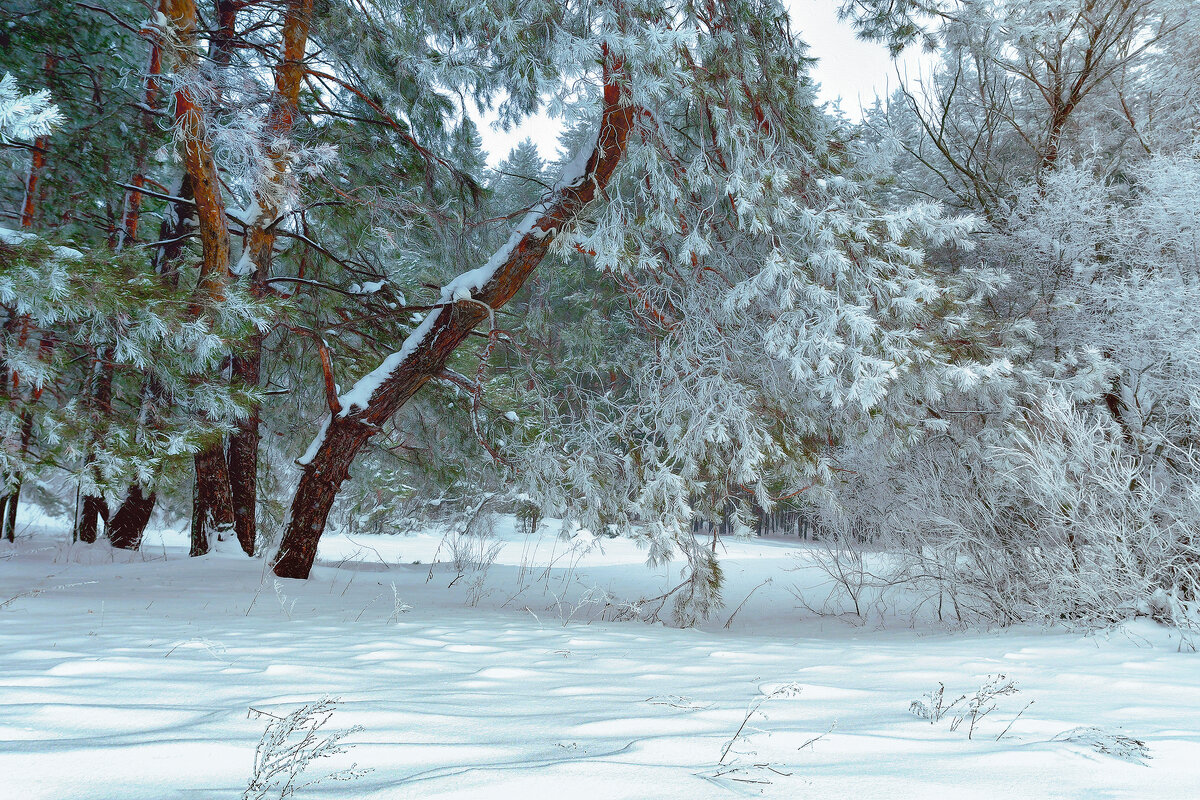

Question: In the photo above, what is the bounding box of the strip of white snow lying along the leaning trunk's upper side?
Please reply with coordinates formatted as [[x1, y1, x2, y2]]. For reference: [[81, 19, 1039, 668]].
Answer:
[[296, 133, 599, 467]]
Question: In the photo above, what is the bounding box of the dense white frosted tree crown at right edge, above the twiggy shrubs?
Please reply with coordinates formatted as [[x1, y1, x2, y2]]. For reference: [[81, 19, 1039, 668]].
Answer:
[[1010, 149, 1200, 453]]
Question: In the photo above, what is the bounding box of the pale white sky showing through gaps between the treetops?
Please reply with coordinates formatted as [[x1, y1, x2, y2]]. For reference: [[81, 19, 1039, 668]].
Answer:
[[480, 0, 919, 166]]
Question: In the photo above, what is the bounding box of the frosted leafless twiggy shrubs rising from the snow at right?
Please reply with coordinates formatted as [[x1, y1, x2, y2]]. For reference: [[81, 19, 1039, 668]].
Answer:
[[823, 395, 1200, 628]]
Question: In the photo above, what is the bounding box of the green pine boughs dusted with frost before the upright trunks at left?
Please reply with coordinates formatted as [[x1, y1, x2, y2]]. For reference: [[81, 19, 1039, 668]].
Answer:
[[0, 237, 268, 495]]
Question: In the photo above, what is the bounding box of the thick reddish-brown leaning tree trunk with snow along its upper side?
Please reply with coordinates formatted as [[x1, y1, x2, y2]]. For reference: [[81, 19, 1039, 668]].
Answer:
[[268, 61, 635, 578]]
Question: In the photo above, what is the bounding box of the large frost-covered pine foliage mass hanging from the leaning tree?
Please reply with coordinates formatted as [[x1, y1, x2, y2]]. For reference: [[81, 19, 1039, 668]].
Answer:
[[511, 4, 1012, 618]]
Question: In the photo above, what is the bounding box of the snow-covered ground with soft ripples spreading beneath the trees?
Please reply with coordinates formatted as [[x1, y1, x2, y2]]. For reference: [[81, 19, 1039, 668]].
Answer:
[[0, 521, 1200, 800]]
